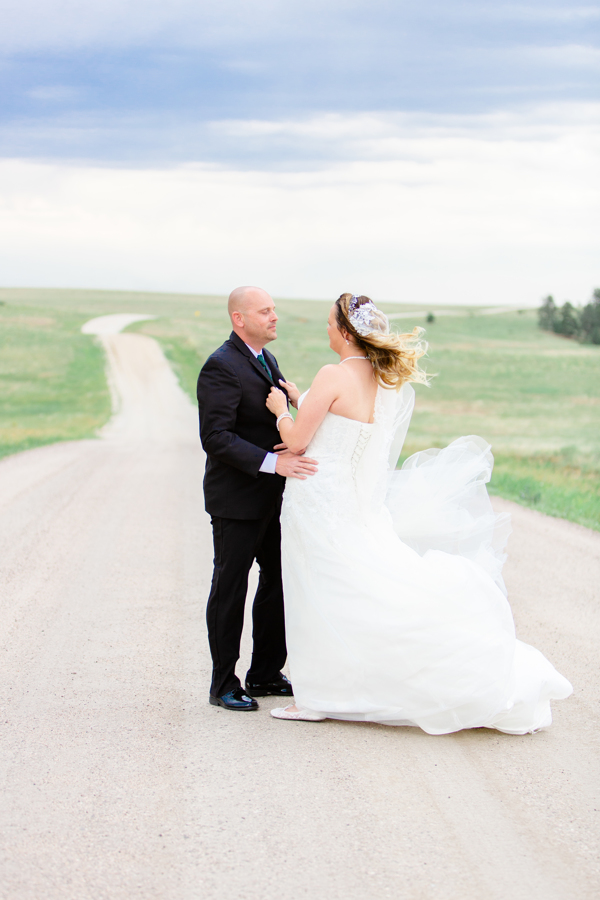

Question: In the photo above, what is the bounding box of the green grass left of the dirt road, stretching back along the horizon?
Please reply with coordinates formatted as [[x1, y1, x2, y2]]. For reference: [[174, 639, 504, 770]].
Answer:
[[0, 288, 226, 457]]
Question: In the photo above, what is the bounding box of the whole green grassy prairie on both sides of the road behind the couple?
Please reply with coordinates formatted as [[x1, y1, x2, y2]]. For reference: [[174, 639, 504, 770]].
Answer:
[[0, 290, 600, 530]]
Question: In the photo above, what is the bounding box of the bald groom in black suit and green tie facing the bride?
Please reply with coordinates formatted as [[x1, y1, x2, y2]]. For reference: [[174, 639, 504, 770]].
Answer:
[[197, 287, 316, 710]]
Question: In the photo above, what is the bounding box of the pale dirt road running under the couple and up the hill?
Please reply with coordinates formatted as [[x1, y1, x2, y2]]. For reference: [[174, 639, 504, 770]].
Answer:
[[0, 323, 600, 900]]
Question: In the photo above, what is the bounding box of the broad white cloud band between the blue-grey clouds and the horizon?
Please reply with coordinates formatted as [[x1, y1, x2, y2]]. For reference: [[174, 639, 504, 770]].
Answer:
[[0, 106, 600, 305]]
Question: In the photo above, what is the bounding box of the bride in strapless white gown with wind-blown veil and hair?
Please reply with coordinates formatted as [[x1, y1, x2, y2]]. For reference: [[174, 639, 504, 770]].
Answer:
[[267, 294, 572, 734]]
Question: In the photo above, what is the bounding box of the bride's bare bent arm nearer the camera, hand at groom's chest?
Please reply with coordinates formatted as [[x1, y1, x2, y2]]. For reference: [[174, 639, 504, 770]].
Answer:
[[267, 366, 344, 453]]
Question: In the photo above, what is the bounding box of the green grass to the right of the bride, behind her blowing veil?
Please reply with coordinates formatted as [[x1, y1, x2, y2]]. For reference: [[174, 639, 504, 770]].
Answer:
[[406, 312, 600, 530]]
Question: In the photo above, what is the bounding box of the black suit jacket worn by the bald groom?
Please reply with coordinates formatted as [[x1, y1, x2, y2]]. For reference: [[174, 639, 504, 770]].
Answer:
[[197, 332, 285, 519]]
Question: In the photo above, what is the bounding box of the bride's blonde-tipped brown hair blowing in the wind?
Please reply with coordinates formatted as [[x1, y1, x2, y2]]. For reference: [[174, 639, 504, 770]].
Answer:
[[335, 294, 429, 391]]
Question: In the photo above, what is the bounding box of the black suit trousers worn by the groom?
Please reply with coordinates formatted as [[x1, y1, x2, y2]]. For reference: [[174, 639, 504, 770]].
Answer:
[[206, 507, 287, 697]]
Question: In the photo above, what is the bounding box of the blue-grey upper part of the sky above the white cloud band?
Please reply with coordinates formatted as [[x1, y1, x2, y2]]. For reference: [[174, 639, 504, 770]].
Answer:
[[0, 0, 600, 167]]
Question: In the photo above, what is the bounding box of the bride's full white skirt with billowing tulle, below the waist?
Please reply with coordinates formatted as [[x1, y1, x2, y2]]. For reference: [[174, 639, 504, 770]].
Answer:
[[282, 438, 572, 734]]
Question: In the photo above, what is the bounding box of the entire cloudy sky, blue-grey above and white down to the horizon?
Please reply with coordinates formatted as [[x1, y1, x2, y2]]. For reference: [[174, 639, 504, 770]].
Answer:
[[0, 0, 600, 306]]
